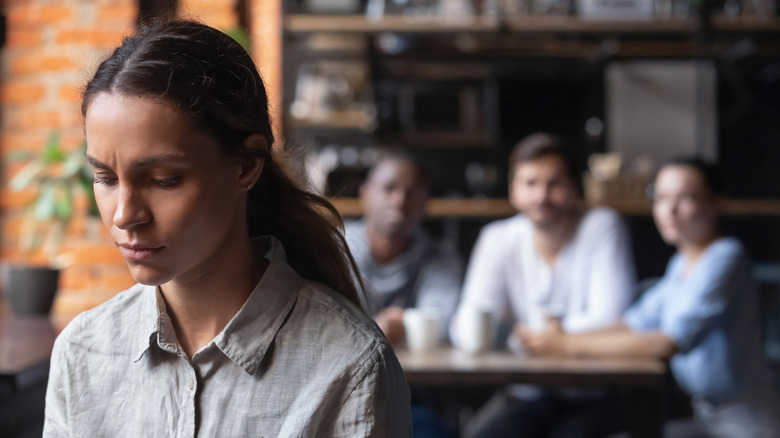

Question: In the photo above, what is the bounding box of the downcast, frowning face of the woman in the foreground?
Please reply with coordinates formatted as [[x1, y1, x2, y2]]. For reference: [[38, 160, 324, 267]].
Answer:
[[84, 93, 246, 285]]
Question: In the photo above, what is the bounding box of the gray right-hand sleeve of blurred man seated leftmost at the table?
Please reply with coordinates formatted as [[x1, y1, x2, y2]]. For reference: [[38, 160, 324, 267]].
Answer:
[[415, 248, 463, 338]]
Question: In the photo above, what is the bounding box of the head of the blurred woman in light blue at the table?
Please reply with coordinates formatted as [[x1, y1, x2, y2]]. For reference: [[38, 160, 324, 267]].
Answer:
[[653, 165, 717, 245]]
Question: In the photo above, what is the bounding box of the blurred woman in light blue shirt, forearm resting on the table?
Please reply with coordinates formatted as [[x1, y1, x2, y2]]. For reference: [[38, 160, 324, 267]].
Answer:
[[522, 158, 780, 438]]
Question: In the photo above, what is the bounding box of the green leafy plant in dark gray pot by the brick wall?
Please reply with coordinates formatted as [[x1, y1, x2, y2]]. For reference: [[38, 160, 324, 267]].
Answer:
[[2, 133, 97, 315]]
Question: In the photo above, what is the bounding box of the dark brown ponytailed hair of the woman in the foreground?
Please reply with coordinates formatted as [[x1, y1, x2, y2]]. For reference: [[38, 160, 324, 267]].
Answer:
[[81, 20, 360, 305]]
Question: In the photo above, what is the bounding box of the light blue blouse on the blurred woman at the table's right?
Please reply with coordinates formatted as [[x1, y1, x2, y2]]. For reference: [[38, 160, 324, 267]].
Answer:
[[624, 238, 771, 403]]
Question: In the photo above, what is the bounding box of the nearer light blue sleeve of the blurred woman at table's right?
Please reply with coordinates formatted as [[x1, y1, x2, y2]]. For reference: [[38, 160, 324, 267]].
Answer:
[[661, 242, 755, 353]]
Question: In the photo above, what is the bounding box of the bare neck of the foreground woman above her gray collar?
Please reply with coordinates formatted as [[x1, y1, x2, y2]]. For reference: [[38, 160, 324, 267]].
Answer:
[[160, 239, 267, 358]]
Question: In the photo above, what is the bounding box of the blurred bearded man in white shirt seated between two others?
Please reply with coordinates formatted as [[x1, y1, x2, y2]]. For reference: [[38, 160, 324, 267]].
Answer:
[[451, 133, 635, 437]]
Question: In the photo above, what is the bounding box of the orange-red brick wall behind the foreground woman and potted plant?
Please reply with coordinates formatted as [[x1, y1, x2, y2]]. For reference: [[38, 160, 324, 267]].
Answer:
[[0, 0, 281, 315]]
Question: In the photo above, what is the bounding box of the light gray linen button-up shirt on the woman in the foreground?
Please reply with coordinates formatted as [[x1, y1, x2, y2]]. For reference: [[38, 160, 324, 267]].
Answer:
[[43, 238, 411, 437]]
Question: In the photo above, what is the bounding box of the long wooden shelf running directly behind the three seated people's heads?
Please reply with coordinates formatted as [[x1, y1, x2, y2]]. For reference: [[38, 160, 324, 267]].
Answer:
[[331, 198, 780, 218]]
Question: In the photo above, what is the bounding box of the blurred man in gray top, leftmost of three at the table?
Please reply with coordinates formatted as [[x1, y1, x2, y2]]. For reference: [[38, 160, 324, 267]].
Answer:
[[344, 154, 463, 344]]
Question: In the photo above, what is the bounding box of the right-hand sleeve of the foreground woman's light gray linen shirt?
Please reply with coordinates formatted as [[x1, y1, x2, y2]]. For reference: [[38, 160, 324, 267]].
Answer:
[[330, 346, 412, 438]]
